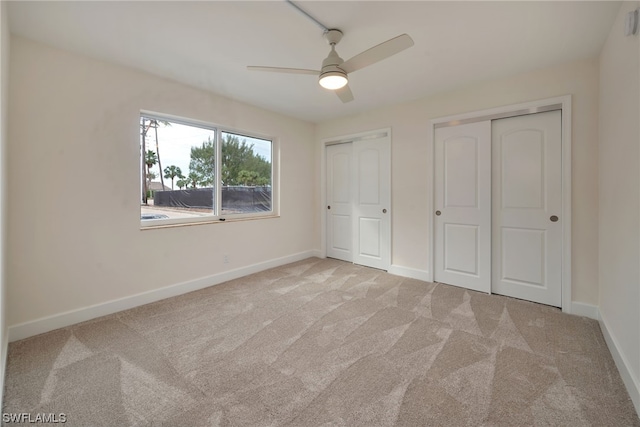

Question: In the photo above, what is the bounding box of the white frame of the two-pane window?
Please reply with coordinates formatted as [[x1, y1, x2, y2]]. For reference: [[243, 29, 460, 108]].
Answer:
[[138, 110, 280, 230]]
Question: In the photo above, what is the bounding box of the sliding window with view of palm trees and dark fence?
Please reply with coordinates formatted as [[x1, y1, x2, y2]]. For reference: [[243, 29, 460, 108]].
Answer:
[[140, 113, 274, 227]]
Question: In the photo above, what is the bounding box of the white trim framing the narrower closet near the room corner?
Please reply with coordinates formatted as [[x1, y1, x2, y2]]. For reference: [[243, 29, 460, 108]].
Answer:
[[320, 127, 393, 271]]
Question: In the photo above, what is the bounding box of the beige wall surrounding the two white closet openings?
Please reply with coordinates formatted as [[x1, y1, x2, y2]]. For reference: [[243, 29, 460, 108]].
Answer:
[[316, 60, 598, 305]]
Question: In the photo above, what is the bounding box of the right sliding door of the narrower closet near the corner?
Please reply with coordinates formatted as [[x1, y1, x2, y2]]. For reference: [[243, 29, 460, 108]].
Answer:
[[352, 135, 391, 270]]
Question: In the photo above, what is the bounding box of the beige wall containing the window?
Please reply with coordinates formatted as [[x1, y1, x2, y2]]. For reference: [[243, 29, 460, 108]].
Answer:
[[7, 36, 317, 325]]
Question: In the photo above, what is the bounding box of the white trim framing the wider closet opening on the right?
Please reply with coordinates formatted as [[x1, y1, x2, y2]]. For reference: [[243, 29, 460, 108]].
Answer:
[[427, 95, 571, 313]]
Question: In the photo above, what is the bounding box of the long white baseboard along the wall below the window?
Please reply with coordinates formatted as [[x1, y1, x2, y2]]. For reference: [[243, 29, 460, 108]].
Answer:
[[8, 250, 320, 341]]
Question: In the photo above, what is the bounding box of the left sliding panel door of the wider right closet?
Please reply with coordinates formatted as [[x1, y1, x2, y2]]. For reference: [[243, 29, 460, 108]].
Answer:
[[434, 121, 491, 293]]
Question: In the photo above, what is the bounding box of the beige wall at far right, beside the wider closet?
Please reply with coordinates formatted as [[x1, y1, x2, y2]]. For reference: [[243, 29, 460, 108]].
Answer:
[[599, 2, 640, 407]]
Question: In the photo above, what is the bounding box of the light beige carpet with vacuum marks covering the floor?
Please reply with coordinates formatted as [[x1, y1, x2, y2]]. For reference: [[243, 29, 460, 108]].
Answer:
[[4, 258, 640, 427]]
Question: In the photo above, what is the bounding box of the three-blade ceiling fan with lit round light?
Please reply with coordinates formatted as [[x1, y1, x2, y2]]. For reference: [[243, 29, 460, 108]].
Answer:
[[247, 28, 413, 102]]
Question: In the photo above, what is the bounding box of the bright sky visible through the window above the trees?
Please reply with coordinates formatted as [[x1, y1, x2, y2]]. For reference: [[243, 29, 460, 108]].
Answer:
[[141, 119, 271, 189]]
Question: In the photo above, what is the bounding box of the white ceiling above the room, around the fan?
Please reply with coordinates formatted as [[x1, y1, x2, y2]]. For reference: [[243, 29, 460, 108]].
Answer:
[[9, 1, 622, 122]]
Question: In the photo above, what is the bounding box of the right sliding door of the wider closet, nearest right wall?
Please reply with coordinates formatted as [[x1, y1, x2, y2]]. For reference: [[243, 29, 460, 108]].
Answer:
[[492, 111, 562, 307]]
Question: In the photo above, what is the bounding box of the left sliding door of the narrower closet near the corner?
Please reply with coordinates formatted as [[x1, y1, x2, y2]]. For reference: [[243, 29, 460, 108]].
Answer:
[[326, 143, 353, 262]]
